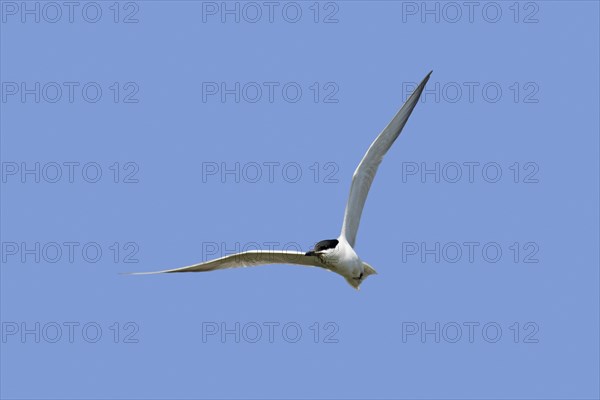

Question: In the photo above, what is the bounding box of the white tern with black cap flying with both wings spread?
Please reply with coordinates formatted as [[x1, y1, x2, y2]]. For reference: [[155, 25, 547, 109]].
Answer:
[[133, 71, 433, 290]]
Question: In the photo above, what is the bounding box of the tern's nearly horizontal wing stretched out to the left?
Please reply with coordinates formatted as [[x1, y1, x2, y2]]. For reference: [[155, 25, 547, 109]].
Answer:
[[126, 250, 327, 275]]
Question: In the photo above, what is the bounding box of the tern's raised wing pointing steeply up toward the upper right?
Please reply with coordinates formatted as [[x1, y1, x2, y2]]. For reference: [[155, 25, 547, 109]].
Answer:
[[342, 72, 431, 247]]
